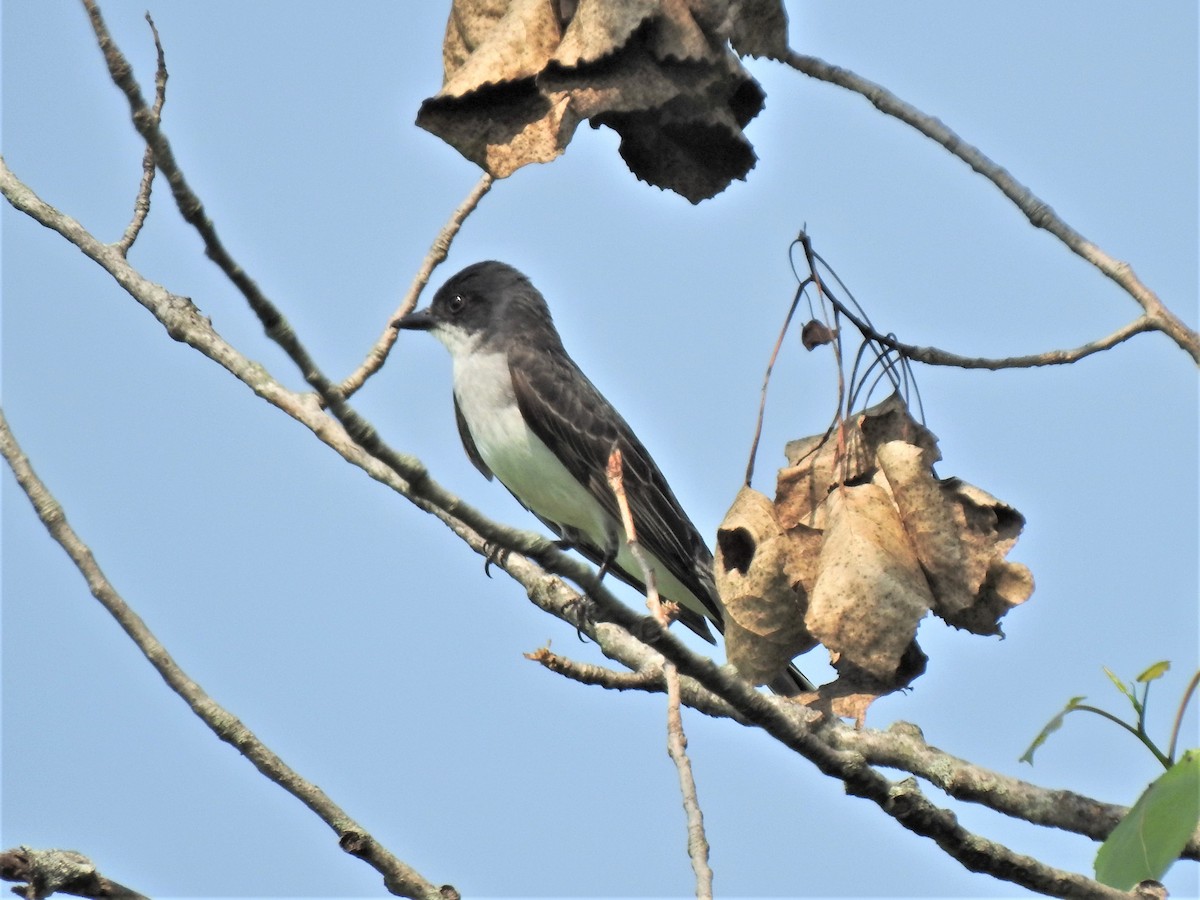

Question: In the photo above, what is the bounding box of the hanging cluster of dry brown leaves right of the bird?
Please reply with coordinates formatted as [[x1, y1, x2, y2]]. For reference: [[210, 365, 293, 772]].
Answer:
[[716, 395, 1033, 720]]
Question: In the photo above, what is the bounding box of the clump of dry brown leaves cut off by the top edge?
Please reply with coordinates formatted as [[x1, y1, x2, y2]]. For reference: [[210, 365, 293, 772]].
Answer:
[[416, 0, 787, 203]]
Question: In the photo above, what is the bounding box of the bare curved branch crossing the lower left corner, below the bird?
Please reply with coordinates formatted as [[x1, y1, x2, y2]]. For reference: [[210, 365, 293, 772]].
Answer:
[[0, 409, 458, 900]]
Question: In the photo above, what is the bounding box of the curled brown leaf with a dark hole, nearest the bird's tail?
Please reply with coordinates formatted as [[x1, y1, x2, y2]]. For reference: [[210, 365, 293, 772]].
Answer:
[[714, 487, 821, 684]]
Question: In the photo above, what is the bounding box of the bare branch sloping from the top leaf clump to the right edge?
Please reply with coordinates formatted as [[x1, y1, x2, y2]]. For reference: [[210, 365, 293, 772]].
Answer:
[[778, 49, 1200, 368]]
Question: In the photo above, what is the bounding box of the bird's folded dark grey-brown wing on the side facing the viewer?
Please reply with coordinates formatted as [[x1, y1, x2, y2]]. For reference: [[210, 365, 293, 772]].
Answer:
[[509, 340, 722, 640]]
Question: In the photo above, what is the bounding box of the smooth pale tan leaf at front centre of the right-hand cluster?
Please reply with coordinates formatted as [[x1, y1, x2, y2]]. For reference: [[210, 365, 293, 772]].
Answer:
[[805, 484, 934, 684]]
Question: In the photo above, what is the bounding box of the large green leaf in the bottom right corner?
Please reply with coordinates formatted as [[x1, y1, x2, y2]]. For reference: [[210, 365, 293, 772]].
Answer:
[[1096, 750, 1200, 890]]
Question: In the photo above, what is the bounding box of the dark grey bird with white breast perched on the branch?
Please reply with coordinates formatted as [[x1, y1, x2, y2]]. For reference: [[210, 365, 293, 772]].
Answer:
[[394, 260, 812, 695]]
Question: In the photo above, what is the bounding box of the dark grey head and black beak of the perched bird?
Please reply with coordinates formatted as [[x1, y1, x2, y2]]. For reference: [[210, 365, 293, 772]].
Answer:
[[396, 260, 562, 355]]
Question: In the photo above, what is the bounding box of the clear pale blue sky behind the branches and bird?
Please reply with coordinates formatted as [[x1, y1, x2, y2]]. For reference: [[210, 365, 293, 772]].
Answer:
[[0, 0, 1200, 896]]
